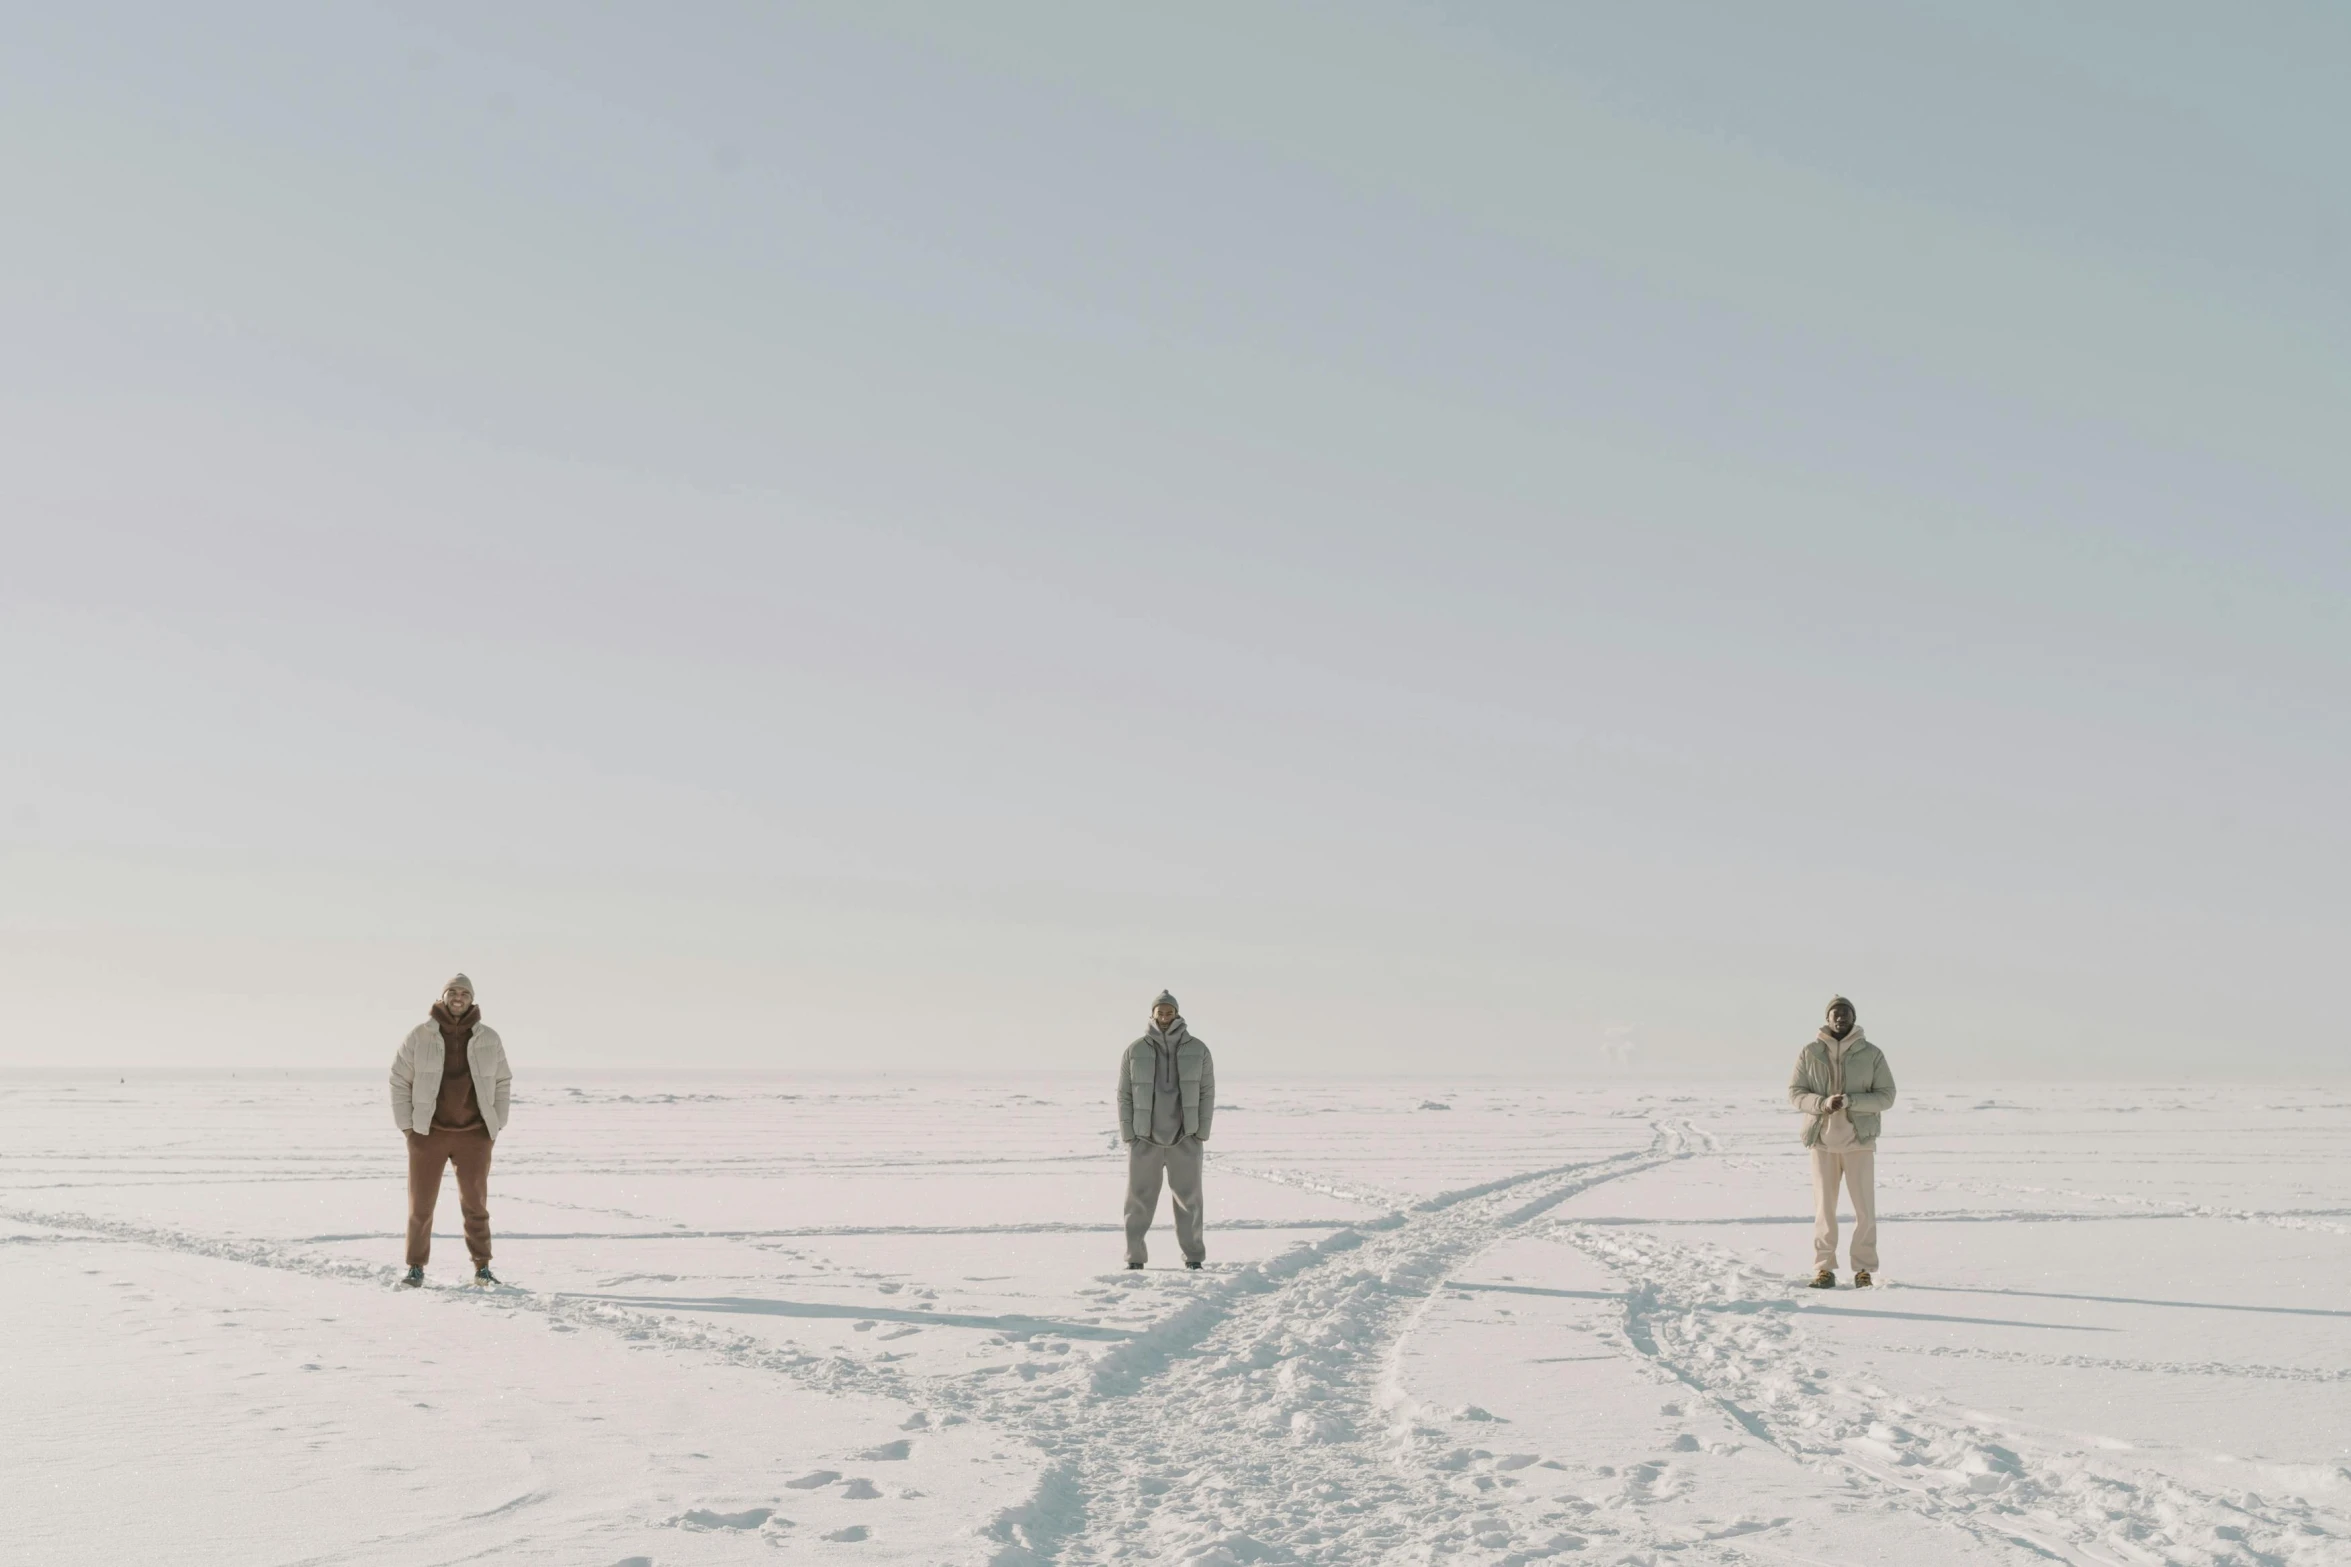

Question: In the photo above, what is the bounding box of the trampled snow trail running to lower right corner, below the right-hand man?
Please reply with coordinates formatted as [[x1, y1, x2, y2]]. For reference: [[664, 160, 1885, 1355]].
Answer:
[[1554, 1222, 2351, 1567]]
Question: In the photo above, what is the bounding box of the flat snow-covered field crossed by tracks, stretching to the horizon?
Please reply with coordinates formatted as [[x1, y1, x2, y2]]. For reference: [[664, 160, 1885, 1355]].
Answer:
[[0, 1071, 2351, 1567]]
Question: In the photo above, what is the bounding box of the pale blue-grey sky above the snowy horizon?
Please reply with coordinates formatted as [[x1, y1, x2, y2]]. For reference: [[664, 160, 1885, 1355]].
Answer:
[[0, 0, 2351, 1092]]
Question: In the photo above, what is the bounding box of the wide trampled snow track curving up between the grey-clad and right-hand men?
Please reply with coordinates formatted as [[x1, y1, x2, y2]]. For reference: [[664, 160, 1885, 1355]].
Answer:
[[973, 1125, 1695, 1567]]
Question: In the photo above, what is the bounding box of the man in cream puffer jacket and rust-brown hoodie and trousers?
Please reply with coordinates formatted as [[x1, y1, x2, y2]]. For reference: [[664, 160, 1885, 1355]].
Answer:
[[393, 975, 515, 1287]]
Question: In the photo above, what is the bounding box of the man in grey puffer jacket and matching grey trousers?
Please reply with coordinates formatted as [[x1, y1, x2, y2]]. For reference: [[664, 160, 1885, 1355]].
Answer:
[[1117, 991, 1215, 1269]]
